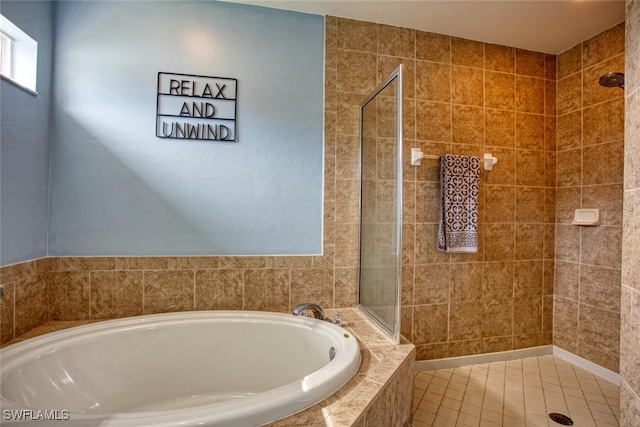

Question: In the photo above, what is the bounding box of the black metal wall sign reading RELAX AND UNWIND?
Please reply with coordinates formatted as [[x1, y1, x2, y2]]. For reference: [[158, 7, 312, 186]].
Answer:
[[156, 72, 238, 141]]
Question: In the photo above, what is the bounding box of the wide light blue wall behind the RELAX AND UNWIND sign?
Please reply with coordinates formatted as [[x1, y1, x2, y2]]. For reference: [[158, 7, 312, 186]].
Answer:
[[48, 1, 324, 256]]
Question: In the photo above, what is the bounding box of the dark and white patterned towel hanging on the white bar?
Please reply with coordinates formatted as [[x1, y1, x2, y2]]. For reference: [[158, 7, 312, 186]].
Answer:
[[438, 154, 480, 253]]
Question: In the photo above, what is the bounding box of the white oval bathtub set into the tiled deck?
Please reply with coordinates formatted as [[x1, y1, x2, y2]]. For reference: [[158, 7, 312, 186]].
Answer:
[[0, 311, 360, 427]]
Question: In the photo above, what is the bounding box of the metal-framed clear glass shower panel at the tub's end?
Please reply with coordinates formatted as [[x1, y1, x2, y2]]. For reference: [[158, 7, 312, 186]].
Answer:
[[358, 65, 402, 343]]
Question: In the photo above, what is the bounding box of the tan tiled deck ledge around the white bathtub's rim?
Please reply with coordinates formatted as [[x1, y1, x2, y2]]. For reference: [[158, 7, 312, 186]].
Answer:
[[1, 308, 415, 427]]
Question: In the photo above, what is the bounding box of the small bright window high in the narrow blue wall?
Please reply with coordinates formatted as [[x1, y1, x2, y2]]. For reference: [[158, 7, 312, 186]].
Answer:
[[0, 15, 38, 94]]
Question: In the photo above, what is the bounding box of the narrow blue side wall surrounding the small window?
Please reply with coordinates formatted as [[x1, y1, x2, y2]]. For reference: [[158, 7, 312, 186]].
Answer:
[[0, 0, 54, 265]]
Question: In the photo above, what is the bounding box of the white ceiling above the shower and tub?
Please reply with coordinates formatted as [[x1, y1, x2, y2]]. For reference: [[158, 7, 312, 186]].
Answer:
[[227, 0, 625, 54]]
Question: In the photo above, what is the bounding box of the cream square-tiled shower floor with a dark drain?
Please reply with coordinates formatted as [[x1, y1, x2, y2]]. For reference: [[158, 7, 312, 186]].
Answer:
[[413, 355, 620, 427]]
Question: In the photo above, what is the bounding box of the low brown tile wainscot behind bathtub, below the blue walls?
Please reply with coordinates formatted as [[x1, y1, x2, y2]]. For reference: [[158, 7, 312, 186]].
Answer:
[[0, 256, 344, 344]]
